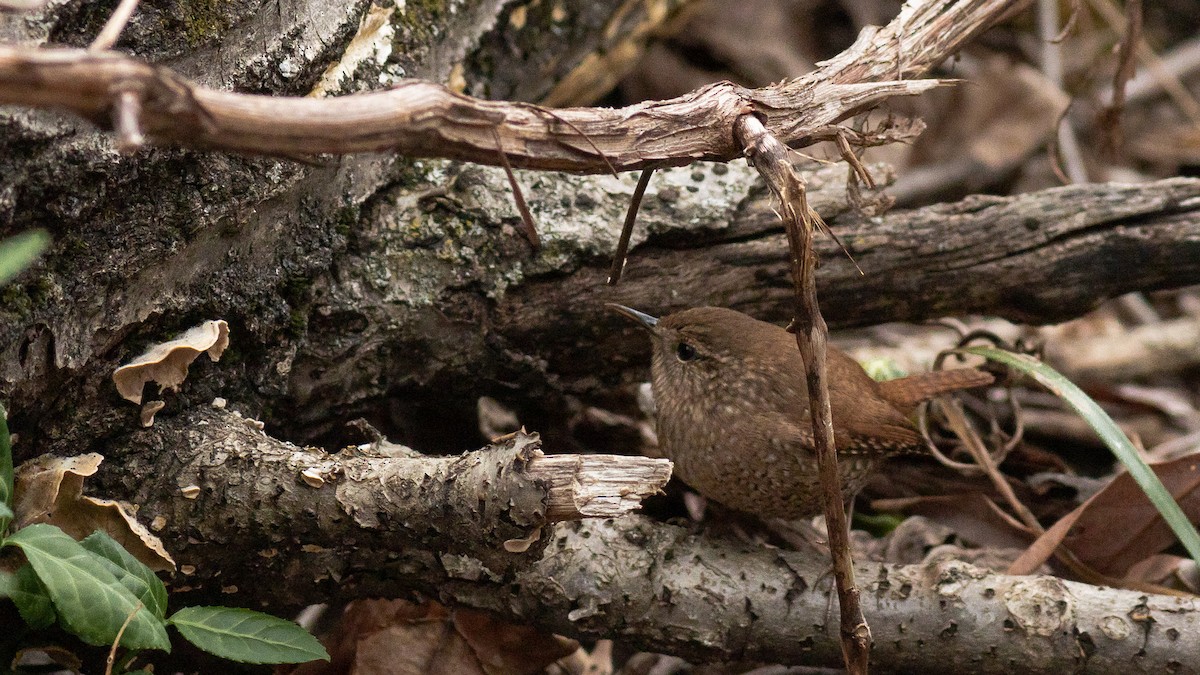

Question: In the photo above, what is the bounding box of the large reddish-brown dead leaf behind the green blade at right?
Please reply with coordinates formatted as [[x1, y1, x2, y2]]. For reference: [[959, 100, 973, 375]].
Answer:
[[1008, 454, 1200, 577]]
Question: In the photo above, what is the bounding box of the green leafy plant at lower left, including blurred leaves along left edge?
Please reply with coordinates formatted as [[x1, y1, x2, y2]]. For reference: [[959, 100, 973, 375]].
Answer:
[[0, 229, 329, 665]]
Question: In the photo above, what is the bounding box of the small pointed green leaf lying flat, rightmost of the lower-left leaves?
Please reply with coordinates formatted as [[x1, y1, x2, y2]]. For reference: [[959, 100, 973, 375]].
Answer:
[[167, 607, 329, 663]]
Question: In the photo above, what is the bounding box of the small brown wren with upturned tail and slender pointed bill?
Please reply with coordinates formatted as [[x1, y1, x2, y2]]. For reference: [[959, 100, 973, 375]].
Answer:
[[608, 304, 992, 518]]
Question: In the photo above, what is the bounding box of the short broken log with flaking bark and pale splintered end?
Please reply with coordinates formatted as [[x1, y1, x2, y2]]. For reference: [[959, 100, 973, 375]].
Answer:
[[97, 407, 671, 609]]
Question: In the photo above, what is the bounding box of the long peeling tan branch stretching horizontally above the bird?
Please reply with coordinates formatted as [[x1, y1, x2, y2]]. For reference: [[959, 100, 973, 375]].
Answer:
[[0, 0, 1024, 173]]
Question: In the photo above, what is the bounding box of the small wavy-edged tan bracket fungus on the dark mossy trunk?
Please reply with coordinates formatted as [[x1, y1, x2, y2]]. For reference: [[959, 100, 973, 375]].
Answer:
[[113, 319, 229, 405]]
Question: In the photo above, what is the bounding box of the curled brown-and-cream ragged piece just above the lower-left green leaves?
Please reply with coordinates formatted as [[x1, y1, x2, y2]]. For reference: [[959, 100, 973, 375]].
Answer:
[[13, 453, 175, 572]]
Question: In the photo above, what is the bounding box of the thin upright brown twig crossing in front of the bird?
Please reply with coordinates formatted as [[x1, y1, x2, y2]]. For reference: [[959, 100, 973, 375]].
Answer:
[[733, 114, 871, 674]]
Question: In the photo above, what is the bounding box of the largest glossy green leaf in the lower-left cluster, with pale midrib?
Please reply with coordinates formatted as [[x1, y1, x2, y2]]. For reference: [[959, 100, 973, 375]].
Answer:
[[7, 524, 170, 651]]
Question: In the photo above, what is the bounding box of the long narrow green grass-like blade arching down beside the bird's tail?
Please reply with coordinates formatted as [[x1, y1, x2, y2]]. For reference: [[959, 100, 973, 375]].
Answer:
[[956, 347, 1200, 562]]
